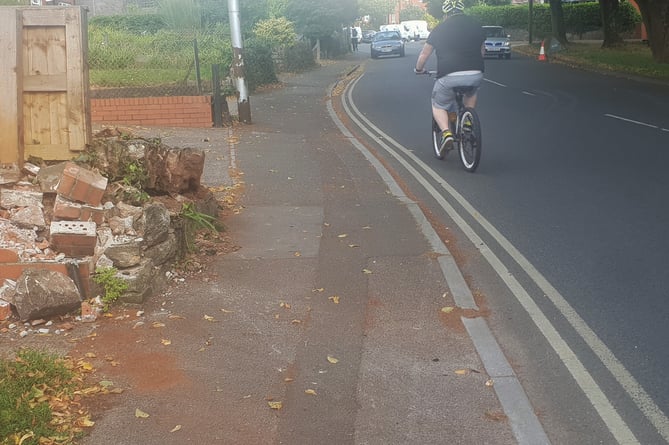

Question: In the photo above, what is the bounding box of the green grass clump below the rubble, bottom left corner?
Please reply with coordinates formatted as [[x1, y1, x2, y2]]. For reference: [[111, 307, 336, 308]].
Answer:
[[0, 349, 75, 445]]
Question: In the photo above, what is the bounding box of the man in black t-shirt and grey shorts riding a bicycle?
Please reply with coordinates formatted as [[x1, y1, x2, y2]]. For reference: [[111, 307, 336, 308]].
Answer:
[[414, 0, 485, 150]]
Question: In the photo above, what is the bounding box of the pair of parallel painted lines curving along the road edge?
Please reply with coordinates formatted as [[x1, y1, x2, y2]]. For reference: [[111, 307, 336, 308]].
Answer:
[[348, 76, 669, 443]]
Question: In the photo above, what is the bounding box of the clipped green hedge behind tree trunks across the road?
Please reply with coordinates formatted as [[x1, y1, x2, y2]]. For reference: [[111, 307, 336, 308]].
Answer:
[[467, 1, 641, 38]]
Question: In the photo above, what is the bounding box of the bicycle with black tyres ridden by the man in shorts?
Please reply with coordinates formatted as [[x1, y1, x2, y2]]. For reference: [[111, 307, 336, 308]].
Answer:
[[419, 71, 482, 173]]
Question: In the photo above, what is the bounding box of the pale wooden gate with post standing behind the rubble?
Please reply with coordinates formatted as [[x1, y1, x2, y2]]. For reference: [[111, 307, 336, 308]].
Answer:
[[0, 6, 91, 165]]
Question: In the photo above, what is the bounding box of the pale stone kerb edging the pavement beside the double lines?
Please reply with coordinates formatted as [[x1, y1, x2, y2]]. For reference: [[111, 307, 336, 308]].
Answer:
[[327, 59, 550, 445]]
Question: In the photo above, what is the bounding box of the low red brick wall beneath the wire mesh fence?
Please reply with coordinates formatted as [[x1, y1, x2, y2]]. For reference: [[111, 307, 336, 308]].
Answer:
[[91, 96, 213, 127]]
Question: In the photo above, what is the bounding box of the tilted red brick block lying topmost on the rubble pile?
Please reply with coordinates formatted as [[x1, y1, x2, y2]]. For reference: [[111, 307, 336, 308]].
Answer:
[[56, 162, 107, 207]]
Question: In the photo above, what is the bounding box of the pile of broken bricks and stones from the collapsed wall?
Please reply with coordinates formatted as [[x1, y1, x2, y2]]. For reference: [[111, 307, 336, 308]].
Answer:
[[0, 132, 218, 323]]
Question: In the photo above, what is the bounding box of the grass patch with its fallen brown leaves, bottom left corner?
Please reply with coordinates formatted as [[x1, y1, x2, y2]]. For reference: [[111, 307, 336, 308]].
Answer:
[[0, 349, 90, 445]]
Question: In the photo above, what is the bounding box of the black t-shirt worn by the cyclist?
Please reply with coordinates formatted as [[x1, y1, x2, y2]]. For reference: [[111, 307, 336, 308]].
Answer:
[[427, 14, 485, 77]]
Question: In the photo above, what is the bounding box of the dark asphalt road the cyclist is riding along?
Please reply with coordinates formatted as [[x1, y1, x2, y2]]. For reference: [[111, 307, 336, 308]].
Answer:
[[348, 43, 669, 443]]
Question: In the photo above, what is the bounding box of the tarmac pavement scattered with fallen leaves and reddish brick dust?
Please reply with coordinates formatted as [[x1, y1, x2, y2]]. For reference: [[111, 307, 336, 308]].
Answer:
[[77, 54, 516, 445]]
